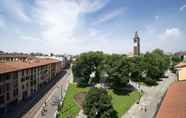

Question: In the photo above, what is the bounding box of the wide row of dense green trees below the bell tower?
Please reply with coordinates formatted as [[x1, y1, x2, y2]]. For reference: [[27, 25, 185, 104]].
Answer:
[[72, 49, 173, 86]]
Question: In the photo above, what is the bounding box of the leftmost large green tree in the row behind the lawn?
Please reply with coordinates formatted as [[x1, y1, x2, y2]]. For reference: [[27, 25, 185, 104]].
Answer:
[[72, 52, 103, 85]]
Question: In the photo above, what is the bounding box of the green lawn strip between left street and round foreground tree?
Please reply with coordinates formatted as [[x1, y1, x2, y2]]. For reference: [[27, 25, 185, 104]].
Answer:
[[60, 84, 89, 118]]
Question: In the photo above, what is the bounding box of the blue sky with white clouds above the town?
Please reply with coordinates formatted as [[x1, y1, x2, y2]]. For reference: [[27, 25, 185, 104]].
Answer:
[[0, 0, 186, 54]]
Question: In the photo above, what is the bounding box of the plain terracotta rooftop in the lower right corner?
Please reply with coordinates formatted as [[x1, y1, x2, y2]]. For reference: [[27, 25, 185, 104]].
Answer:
[[156, 81, 186, 118]]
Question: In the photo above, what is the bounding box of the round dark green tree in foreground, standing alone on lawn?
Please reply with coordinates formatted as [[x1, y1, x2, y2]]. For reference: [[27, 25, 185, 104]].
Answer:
[[83, 88, 117, 118]]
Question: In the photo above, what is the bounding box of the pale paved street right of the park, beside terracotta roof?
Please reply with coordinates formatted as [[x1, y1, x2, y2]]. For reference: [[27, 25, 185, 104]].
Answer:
[[122, 73, 176, 118]]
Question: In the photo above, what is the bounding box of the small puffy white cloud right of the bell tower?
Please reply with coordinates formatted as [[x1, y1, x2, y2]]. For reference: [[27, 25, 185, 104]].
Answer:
[[160, 28, 182, 40]]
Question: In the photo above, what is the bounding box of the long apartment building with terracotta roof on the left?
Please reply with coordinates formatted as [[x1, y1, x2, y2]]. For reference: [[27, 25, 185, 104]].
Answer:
[[0, 56, 61, 109]]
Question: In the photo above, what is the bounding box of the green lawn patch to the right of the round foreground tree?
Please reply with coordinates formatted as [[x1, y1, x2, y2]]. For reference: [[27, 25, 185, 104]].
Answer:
[[109, 90, 140, 118]]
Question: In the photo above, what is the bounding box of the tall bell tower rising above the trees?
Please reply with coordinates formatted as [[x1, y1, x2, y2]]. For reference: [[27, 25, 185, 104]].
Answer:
[[133, 32, 140, 55]]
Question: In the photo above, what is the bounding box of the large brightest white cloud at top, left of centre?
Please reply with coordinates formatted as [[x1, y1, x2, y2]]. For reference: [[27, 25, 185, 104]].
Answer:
[[35, 0, 80, 40]]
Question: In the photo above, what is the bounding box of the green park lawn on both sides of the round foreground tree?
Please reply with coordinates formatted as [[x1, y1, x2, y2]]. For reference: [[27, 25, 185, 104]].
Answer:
[[60, 84, 139, 118]]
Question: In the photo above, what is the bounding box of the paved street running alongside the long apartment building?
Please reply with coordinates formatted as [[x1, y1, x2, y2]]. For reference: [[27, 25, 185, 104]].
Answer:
[[23, 70, 72, 118]]
